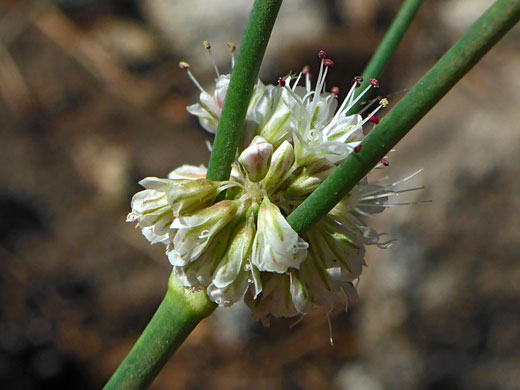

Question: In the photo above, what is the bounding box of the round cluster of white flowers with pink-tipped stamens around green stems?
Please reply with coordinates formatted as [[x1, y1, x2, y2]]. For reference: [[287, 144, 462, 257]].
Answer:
[[128, 44, 420, 321]]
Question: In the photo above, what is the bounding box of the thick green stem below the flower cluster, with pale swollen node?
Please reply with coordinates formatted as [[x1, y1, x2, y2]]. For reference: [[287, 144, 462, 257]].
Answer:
[[104, 275, 216, 390]]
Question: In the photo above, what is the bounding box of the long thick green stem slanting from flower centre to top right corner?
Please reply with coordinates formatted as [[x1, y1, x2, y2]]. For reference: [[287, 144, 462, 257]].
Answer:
[[288, 0, 520, 235]]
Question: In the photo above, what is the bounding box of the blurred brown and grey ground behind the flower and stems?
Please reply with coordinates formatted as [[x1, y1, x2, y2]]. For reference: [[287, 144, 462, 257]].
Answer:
[[0, 0, 520, 390]]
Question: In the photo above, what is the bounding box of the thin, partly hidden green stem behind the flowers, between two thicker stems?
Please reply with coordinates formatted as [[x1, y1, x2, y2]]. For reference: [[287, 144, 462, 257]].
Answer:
[[347, 0, 423, 115]]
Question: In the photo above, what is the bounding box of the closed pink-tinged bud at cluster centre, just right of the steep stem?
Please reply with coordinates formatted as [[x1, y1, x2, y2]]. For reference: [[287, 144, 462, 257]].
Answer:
[[238, 136, 273, 183]]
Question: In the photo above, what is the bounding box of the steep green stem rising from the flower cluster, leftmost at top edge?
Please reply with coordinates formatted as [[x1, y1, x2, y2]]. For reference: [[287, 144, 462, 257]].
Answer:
[[207, 0, 282, 180]]
